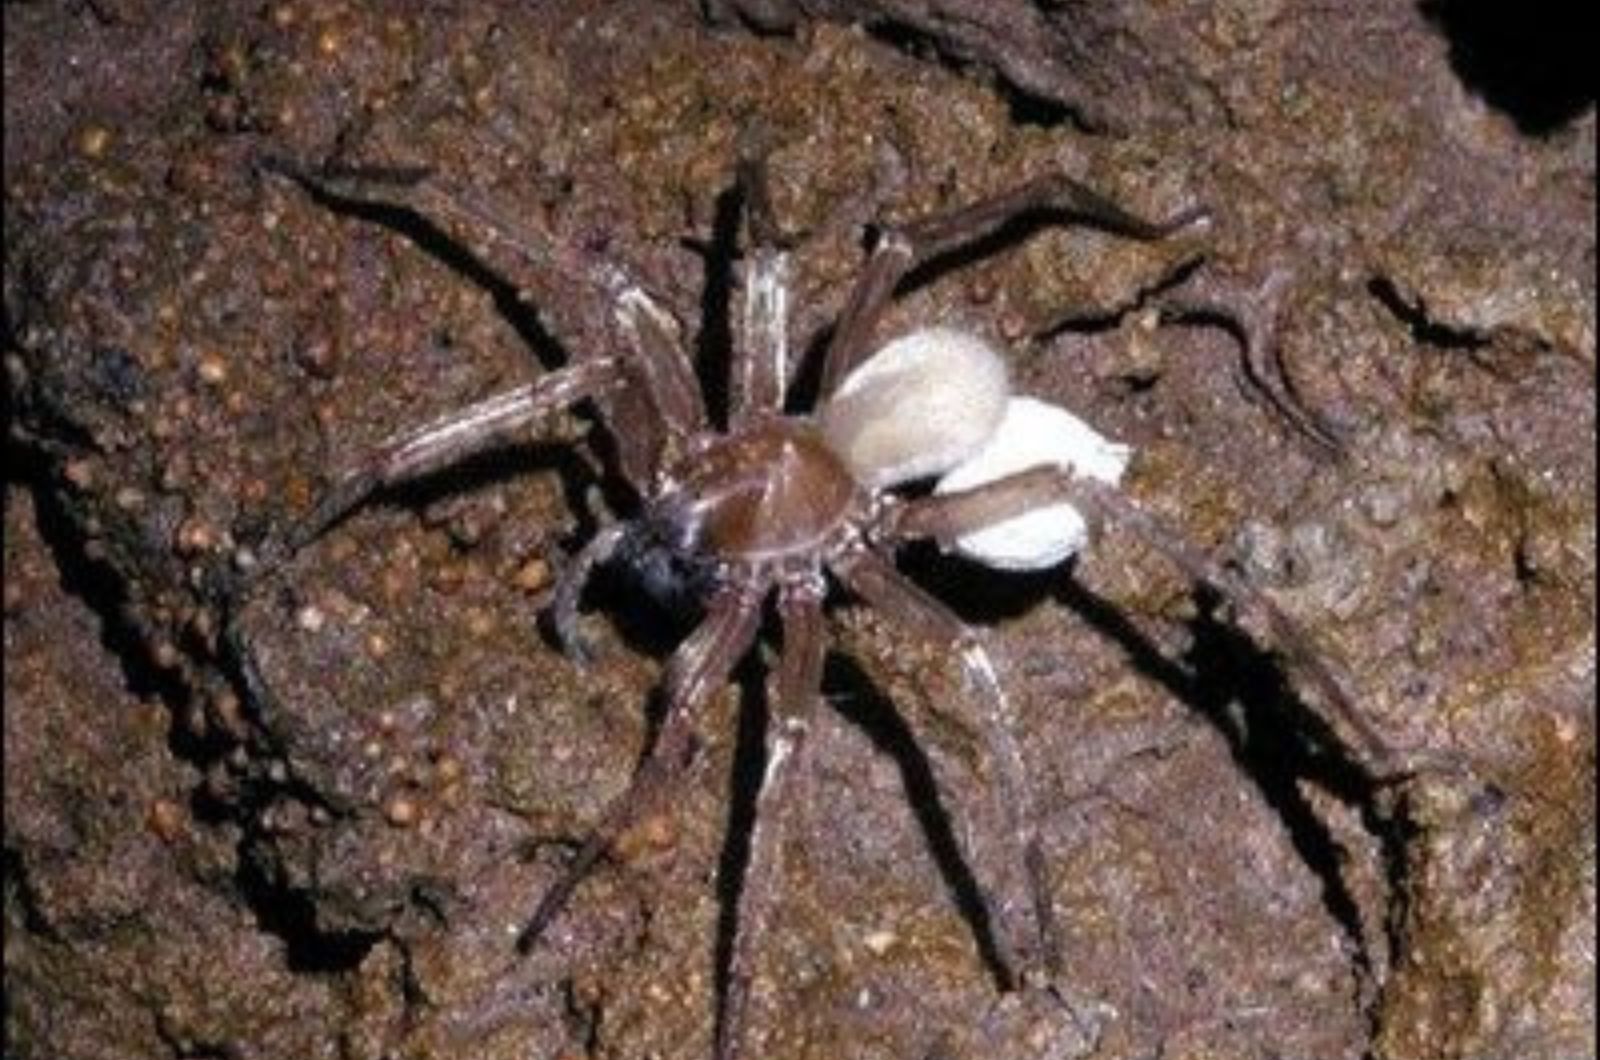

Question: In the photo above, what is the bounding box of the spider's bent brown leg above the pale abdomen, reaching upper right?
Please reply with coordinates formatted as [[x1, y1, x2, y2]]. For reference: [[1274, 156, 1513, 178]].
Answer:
[[822, 173, 1206, 399]]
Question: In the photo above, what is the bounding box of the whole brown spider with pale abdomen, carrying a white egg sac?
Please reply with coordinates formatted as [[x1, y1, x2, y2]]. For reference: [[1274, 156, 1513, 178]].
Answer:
[[264, 143, 1382, 1060]]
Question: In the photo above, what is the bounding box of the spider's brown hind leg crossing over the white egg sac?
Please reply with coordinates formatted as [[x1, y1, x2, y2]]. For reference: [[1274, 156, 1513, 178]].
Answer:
[[883, 466, 1413, 778]]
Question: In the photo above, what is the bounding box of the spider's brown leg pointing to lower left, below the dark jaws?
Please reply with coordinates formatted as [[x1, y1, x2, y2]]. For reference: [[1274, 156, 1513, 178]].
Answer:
[[517, 588, 765, 953]]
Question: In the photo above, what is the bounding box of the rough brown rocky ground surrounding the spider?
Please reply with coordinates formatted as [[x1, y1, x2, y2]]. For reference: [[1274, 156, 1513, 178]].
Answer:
[[5, 0, 1595, 1060]]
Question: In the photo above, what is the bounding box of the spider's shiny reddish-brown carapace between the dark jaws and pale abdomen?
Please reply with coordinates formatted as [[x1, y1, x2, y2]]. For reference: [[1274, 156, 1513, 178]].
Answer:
[[666, 418, 866, 560]]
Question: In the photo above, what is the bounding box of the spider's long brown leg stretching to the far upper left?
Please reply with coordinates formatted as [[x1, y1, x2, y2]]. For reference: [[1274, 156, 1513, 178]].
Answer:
[[259, 159, 706, 490]]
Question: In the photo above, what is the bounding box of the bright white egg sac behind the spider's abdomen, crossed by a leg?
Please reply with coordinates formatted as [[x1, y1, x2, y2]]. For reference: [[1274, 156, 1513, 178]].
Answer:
[[934, 397, 1133, 570]]
